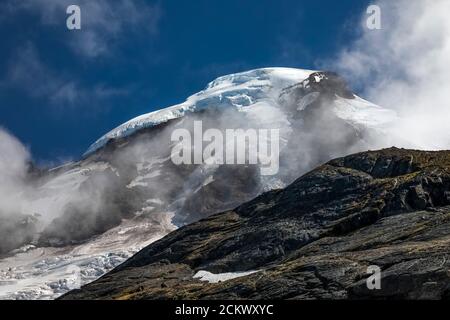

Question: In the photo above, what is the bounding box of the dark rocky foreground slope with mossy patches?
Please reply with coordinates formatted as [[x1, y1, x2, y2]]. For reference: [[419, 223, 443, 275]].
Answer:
[[62, 148, 450, 299]]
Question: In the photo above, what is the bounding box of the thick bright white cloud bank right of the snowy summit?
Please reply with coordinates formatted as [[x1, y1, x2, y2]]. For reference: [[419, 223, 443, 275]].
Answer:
[[327, 0, 450, 149]]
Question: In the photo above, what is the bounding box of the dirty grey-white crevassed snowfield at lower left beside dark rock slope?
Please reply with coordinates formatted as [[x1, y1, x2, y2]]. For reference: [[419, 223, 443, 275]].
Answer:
[[0, 213, 175, 300]]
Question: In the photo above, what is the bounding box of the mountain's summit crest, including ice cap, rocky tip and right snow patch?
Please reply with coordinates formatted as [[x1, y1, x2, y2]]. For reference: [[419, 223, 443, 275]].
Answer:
[[85, 68, 395, 156]]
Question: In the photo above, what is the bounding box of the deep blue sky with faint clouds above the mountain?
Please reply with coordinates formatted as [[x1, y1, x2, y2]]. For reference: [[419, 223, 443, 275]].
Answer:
[[0, 0, 369, 163]]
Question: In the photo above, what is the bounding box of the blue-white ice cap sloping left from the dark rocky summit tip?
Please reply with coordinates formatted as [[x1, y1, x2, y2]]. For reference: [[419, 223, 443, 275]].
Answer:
[[84, 68, 314, 156]]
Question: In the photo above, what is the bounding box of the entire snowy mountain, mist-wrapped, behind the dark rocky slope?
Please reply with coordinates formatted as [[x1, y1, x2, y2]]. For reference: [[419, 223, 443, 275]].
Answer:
[[0, 68, 396, 298]]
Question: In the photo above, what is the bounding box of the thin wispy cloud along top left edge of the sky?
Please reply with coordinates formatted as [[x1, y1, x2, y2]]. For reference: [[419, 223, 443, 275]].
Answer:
[[0, 0, 161, 58]]
